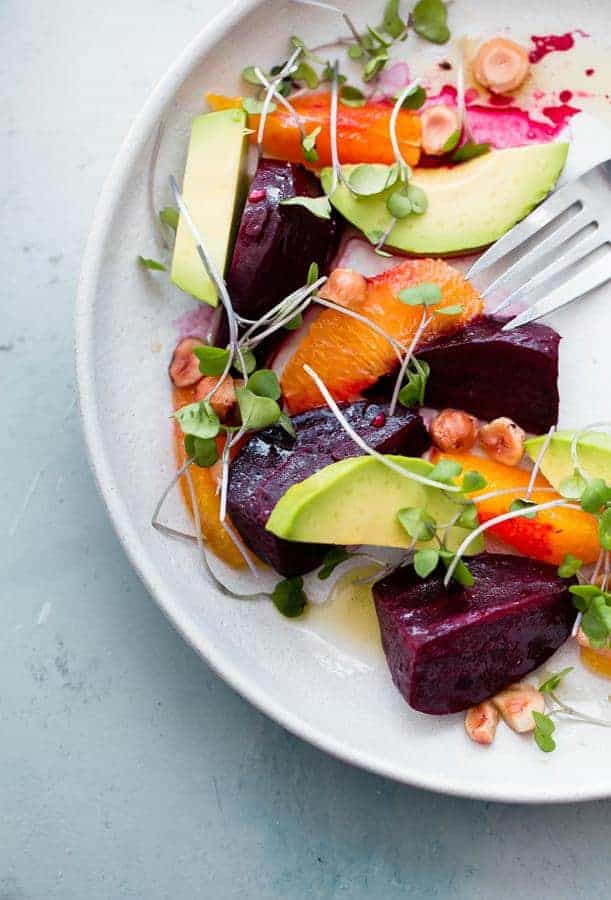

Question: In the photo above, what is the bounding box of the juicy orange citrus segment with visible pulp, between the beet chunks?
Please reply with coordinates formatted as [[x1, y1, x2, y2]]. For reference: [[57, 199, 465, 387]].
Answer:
[[281, 259, 483, 414]]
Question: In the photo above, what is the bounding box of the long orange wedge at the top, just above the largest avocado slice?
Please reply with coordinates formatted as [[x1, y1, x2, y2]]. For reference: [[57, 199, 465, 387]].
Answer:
[[207, 91, 420, 167]]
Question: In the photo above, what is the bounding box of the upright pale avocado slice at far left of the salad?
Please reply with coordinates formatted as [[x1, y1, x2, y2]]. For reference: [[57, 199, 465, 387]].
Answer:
[[171, 109, 247, 306]]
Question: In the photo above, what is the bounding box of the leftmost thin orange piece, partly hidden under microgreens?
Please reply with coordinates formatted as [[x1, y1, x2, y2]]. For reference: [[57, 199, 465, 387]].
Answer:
[[173, 387, 246, 569]]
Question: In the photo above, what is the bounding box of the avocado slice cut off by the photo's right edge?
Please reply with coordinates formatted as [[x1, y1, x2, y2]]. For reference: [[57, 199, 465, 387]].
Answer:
[[525, 431, 611, 490]]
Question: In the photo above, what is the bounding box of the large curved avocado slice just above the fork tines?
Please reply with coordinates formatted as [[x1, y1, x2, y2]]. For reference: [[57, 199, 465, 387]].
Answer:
[[321, 143, 569, 256]]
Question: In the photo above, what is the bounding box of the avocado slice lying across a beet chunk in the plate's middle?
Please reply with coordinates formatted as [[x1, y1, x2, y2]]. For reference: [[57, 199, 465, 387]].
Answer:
[[266, 455, 483, 553]]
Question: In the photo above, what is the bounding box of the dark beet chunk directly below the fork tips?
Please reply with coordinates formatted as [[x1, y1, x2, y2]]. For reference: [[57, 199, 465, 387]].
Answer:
[[418, 316, 560, 434]]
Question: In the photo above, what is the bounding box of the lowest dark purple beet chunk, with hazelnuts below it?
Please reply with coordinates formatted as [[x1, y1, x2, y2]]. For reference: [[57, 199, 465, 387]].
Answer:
[[373, 553, 576, 715]]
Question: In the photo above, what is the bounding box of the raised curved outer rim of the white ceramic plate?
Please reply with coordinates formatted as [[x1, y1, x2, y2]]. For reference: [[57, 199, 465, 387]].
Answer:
[[74, 0, 611, 804]]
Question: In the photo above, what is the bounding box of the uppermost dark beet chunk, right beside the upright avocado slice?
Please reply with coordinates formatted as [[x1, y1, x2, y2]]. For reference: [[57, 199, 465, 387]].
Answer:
[[227, 159, 338, 319]]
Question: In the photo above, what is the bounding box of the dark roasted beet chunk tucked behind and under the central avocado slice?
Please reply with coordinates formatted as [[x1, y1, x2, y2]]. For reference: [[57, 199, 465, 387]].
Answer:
[[227, 400, 430, 575]]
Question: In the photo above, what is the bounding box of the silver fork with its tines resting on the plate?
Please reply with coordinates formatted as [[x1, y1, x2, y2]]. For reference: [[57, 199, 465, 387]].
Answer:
[[467, 159, 611, 331]]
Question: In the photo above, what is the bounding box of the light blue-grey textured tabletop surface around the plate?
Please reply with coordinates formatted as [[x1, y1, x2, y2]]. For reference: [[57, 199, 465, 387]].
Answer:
[[0, 0, 611, 900]]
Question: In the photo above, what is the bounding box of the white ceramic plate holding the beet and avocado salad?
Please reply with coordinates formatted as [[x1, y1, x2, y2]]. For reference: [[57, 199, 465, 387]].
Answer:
[[76, 0, 611, 802]]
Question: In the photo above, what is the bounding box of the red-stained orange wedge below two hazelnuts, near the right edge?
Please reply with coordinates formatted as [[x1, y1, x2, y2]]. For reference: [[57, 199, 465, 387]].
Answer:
[[432, 450, 600, 565]]
